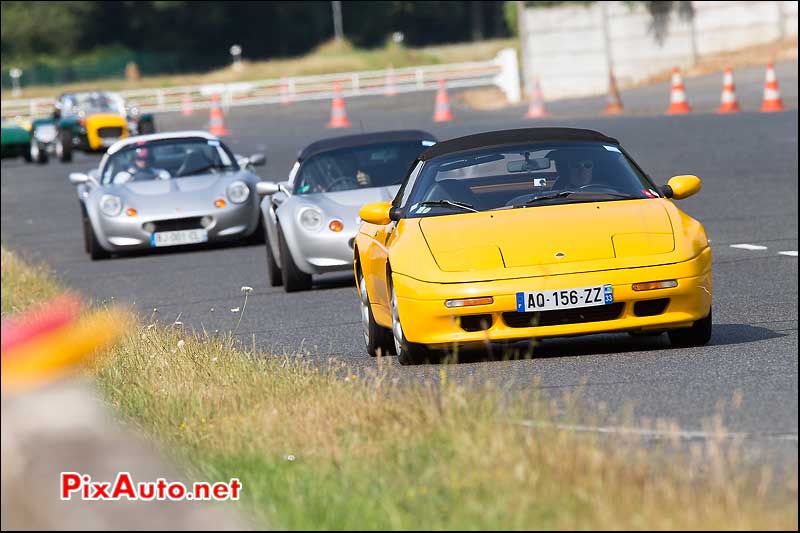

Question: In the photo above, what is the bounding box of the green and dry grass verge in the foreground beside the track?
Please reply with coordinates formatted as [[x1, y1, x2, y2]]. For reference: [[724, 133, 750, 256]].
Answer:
[[2, 247, 797, 529]]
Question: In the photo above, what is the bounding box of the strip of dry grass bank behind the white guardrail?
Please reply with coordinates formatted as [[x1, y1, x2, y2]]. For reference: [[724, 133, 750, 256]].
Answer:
[[2, 39, 515, 98]]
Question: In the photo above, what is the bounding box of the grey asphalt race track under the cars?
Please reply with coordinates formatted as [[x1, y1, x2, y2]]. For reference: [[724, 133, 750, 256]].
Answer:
[[2, 62, 798, 464]]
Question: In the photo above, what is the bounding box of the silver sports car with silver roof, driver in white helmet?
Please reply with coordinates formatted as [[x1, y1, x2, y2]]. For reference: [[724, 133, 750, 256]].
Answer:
[[69, 131, 265, 259]]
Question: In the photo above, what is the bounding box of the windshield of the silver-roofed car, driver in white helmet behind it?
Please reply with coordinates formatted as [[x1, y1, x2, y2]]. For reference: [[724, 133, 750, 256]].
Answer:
[[102, 139, 239, 184]]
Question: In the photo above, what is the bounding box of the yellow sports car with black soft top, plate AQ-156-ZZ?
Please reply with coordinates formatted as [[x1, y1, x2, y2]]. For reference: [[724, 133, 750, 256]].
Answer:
[[354, 128, 712, 364]]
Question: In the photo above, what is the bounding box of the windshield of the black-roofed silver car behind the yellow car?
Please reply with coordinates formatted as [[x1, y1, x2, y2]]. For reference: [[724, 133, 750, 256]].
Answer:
[[294, 141, 433, 194]]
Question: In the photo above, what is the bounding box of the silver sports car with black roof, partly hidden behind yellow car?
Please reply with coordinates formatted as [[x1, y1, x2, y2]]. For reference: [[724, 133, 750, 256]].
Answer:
[[256, 130, 436, 292]]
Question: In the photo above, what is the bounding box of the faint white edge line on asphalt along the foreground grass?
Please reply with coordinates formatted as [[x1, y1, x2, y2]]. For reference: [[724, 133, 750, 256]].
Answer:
[[514, 420, 797, 442]]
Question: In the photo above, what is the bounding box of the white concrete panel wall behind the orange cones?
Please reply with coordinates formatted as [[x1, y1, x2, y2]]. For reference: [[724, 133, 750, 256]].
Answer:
[[520, 1, 797, 99]]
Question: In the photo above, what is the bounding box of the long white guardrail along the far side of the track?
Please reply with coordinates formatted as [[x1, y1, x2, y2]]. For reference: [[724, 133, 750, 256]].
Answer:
[[1, 48, 520, 118]]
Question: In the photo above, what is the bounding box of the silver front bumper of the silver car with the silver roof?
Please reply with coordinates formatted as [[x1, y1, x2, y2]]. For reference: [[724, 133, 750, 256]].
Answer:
[[95, 201, 259, 252]]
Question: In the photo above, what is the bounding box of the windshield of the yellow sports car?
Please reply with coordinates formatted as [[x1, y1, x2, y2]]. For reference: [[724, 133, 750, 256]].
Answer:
[[406, 142, 658, 217]]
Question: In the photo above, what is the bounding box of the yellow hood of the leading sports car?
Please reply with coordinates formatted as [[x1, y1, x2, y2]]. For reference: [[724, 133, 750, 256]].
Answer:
[[419, 199, 675, 272]]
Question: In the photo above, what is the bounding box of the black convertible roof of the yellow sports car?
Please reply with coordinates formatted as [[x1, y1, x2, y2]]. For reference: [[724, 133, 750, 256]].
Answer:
[[419, 128, 619, 161]]
